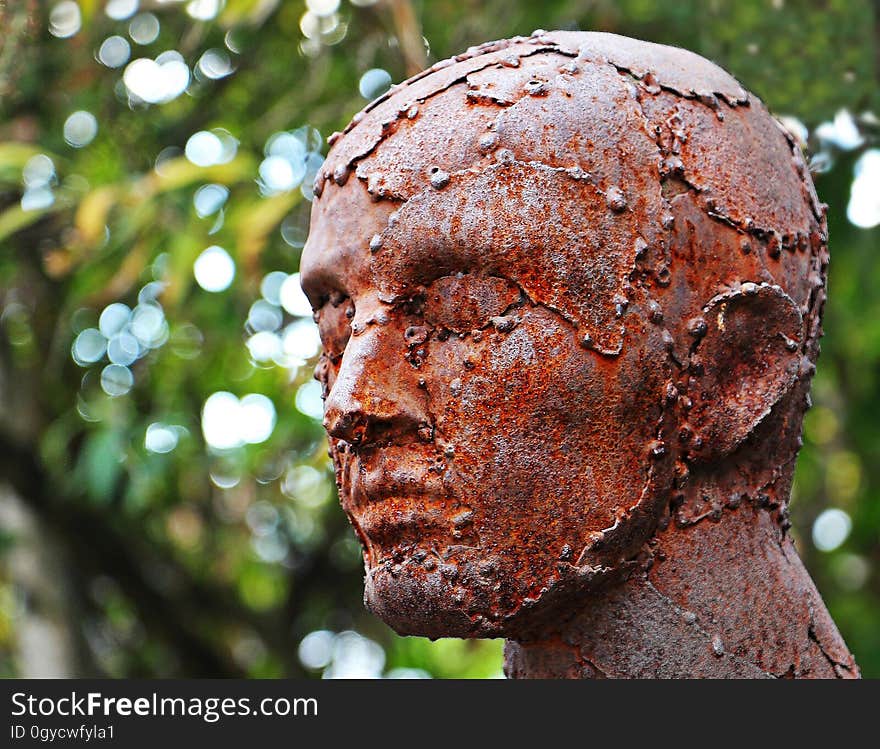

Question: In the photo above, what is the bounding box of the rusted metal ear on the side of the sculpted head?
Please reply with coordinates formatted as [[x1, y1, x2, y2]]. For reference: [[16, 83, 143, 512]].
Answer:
[[687, 283, 803, 461]]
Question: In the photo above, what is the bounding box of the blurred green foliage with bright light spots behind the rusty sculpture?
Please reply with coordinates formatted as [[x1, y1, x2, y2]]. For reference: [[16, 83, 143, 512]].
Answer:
[[0, 0, 880, 677]]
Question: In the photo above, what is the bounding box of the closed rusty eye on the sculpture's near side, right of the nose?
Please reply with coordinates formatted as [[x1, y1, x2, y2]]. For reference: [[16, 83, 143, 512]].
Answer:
[[424, 273, 521, 333]]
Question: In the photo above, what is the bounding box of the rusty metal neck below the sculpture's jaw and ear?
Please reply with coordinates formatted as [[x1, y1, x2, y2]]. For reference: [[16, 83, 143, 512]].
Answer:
[[504, 502, 858, 678]]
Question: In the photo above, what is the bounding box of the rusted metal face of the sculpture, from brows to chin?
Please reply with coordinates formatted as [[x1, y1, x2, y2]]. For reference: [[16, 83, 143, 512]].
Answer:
[[304, 181, 664, 636]]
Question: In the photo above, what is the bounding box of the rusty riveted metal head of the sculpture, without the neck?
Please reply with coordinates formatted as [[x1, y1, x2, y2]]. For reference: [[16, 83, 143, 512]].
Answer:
[[301, 32, 827, 637]]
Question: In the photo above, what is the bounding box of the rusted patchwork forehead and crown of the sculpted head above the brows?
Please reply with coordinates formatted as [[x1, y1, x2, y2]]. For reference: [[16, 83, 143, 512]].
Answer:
[[303, 32, 820, 353]]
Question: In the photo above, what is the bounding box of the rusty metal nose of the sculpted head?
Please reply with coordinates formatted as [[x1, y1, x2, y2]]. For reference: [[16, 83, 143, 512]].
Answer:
[[324, 327, 430, 445]]
